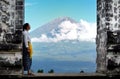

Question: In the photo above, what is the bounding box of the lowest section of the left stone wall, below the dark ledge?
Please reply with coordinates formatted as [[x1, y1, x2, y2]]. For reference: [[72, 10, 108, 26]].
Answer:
[[0, 52, 22, 75]]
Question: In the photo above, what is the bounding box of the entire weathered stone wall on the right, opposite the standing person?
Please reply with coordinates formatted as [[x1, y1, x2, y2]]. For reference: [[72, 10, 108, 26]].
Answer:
[[96, 0, 120, 74]]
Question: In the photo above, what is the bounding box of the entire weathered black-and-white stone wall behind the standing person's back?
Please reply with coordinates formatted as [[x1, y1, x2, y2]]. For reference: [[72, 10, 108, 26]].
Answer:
[[0, 0, 24, 75]]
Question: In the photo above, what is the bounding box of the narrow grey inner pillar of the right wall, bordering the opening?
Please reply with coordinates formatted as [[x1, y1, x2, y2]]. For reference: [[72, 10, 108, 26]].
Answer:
[[96, 0, 107, 72]]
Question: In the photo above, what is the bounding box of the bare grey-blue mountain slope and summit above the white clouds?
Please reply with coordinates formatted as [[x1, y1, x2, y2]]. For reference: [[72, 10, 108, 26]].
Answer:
[[30, 17, 77, 37]]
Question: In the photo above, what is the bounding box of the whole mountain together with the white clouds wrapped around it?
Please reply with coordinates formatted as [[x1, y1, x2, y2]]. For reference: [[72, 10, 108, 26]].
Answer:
[[32, 17, 96, 42]]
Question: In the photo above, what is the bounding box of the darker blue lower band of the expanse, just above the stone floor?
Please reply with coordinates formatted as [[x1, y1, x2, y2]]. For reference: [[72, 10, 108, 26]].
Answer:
[[32, 58, 96, 73]]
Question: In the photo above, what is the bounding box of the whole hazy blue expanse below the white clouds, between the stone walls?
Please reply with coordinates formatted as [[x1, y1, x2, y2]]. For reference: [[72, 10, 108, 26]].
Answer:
[[32, 42, 96, 73]]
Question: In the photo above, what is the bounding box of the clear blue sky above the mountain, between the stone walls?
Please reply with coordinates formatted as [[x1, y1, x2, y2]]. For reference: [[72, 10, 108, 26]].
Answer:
[[25, 0, 96, 31]]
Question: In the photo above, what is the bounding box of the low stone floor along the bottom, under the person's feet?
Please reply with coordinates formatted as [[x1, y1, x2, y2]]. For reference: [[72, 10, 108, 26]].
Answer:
[[0, 73, 120, 79]]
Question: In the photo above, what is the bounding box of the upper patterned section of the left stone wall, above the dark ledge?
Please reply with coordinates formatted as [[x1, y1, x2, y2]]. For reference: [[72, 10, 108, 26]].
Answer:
[[0, 0, 24, 47]]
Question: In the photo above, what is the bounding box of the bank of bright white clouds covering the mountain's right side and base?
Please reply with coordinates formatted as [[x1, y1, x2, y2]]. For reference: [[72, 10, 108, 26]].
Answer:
[[32, 20, 96, 42]]
